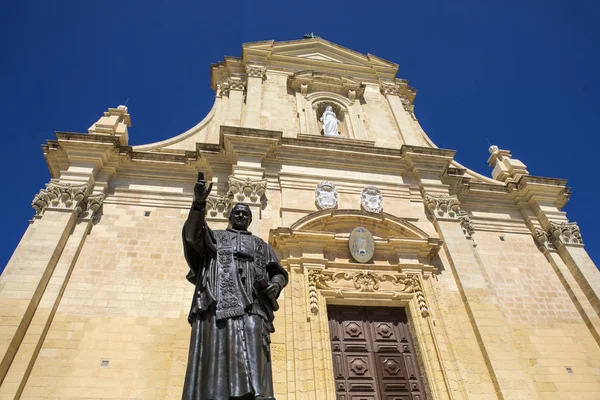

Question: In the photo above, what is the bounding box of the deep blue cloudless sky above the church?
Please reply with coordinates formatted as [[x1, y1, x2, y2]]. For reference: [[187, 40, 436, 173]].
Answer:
[[0, 0, 600, 270]]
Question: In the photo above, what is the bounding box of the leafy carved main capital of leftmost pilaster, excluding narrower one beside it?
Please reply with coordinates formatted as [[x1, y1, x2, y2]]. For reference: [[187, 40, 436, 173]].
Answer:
[[31, 182, 88, 217]]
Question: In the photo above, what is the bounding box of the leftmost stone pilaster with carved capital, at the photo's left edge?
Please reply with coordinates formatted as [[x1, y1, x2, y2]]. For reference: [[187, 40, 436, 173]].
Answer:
[[0, 182, 102, 382]]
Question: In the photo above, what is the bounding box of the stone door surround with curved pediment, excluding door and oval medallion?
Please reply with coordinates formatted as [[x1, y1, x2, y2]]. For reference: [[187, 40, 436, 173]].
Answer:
[[269, 209, 454, 400]]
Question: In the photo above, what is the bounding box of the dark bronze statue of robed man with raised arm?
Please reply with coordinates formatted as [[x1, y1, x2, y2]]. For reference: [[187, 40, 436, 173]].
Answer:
[[183, 174, 288, 400]]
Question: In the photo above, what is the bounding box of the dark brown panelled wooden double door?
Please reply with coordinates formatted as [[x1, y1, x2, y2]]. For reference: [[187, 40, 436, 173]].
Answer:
[[327, 306, 426, 400]]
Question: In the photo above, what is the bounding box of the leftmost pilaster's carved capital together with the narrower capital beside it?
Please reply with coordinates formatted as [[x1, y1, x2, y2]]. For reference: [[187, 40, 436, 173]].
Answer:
[[31, 182, 104, 219]]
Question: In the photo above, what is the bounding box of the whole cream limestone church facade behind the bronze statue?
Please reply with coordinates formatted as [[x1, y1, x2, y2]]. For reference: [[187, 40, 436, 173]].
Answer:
[[0, 38, 600, 400]]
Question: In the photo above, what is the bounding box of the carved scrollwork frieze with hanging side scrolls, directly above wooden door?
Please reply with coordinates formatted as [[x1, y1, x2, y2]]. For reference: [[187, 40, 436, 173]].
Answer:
[[308, 270, 429, 317]]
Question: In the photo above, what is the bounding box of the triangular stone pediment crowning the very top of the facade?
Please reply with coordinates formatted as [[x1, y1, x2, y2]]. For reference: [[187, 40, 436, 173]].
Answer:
[[242, 38, 398, 80]]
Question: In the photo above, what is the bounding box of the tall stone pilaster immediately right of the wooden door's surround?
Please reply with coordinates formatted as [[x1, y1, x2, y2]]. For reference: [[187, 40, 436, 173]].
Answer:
[[403, 147, 536, 400]]
